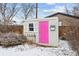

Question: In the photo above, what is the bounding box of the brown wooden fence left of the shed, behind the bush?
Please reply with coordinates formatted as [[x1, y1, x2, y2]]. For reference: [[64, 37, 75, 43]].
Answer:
[[0, 25, 23, 34]]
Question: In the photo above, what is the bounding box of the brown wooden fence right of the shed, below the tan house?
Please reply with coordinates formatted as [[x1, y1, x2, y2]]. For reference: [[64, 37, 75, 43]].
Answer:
[[59, 26, 79, 37]]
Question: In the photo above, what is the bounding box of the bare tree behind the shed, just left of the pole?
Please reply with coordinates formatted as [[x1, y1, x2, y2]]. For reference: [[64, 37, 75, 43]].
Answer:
[[21, 3, 34, 20]]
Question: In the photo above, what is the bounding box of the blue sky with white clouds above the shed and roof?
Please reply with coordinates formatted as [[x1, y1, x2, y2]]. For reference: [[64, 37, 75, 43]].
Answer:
[[14, 3, 73, 23]]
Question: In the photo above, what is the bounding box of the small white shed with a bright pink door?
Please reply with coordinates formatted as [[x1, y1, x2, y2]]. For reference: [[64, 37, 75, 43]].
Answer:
[[24, 17, 59, 46]]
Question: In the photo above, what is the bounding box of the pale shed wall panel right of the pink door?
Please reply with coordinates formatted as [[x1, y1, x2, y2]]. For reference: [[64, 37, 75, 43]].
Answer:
[[49, 19, 58, 46]]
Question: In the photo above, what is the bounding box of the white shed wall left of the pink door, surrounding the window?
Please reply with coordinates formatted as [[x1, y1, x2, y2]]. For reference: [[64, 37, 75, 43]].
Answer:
[[24, 21, 38, 42]]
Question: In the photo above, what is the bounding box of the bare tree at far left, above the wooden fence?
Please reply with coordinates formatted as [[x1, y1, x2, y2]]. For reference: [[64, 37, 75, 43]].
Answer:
[[0, 3, 20, 25]]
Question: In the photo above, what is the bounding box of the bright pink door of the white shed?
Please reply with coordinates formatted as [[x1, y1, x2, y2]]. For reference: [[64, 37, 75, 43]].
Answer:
[[39, 21, 48, 44]]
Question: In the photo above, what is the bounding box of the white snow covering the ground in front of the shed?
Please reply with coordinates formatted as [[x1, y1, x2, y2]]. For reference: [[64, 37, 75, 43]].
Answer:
[[0, 40, 76, 56]]
